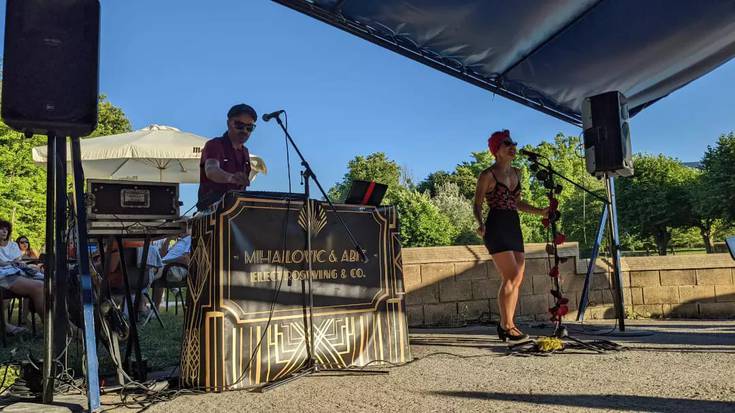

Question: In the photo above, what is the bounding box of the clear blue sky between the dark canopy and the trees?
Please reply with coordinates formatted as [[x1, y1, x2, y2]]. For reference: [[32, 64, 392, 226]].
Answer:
[[0, 0, 735, 212]]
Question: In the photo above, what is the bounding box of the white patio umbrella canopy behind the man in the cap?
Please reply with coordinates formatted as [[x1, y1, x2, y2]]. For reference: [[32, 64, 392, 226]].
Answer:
[[33, 125, 268, 183]]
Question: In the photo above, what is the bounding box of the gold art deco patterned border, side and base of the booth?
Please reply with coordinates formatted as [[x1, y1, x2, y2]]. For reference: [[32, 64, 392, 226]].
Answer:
[[181, 198, 411, 391]]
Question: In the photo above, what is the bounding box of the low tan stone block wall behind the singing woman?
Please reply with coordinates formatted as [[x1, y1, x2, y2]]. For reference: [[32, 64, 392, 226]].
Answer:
[[403, 243, 735, 326]]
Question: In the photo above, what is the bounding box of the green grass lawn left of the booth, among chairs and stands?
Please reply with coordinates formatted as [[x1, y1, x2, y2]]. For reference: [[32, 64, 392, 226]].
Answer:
[[0, 306, 184, 391]]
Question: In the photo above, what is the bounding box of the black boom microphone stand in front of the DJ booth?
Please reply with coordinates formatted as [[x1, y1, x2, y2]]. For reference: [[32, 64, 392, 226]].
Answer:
[[257, 113, 388, 392]]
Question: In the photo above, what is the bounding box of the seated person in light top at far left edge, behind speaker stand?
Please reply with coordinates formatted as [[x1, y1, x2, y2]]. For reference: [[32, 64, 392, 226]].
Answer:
[[0, 219, 44, 332]]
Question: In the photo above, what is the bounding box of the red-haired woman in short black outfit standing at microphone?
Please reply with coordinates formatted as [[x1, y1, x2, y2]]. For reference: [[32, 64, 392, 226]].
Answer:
[[474, 130, 548, 341]]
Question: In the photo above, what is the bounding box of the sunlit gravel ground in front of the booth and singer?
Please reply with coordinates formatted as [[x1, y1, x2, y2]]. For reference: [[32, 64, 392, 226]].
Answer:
[[5, 320, 735, 413]]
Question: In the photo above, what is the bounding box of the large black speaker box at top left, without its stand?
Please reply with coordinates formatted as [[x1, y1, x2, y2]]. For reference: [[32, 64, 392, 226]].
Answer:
[[2, 0, 100, 136]]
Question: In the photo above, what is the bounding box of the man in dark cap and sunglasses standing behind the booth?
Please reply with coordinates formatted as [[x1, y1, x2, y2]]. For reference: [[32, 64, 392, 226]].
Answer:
[[197, 103, 258, 211]]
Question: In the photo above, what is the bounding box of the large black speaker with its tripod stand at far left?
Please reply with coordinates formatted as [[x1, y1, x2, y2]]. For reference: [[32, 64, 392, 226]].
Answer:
[[1, 0, 100, 411]]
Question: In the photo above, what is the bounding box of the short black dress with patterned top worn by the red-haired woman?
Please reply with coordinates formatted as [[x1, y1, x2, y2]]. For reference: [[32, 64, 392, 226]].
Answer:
[[484, 170, 524, 254]]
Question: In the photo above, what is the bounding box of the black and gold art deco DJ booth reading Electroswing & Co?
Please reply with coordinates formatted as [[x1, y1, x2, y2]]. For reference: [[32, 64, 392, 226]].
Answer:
[[181, 192, 411, 391]]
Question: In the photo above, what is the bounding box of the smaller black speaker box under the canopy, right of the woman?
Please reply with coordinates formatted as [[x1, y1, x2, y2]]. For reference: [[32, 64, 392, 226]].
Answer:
[[582, 92, 633, 177]]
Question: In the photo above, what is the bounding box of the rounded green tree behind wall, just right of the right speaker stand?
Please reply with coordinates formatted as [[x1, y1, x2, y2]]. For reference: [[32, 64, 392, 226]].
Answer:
[[616, 155, 692, 255]]
